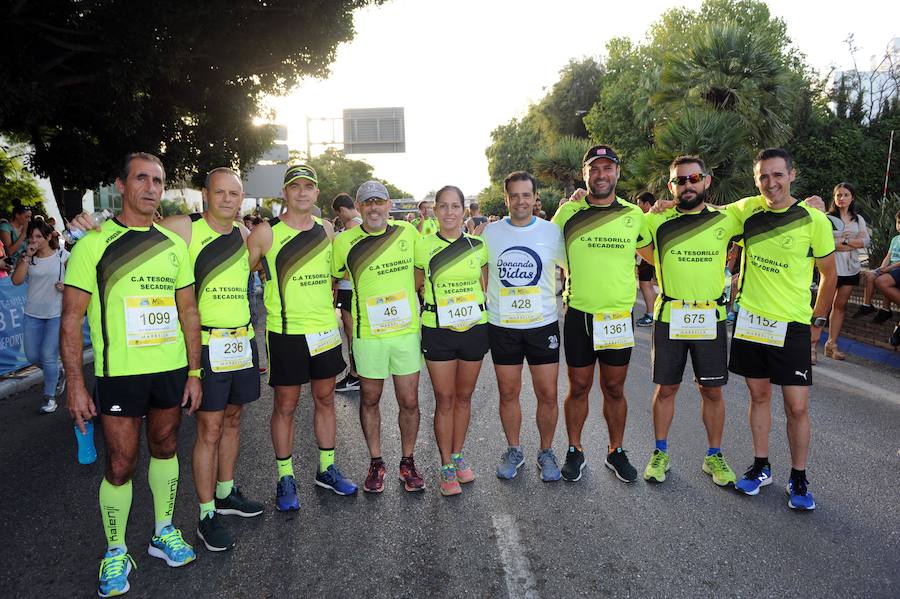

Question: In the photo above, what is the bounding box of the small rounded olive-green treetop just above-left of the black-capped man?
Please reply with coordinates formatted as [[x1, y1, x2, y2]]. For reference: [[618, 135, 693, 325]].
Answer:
[[533, 58, 603, 141]]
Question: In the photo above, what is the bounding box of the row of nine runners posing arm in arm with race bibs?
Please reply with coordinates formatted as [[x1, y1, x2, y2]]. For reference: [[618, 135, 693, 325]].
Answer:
[[61, 145, 835, 597]]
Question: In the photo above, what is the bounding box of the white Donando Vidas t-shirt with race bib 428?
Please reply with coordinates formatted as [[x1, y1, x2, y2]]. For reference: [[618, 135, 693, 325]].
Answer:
[[482, 217, 566, 329]]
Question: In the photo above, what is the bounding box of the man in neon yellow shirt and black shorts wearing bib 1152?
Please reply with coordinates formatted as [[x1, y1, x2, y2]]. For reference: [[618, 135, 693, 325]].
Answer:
[[727, 148, 837, 510]]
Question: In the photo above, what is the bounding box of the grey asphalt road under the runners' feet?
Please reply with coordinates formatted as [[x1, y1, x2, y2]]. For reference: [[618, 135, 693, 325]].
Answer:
[[0, 298, 900, 598]]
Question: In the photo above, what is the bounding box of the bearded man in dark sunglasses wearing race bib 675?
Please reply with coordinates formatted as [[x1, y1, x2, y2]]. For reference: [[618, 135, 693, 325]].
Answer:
[[644, 156, 742, 486]]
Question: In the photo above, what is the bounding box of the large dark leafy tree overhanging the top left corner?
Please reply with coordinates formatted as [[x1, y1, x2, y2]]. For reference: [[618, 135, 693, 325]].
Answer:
[[0, 0, 378, 218]]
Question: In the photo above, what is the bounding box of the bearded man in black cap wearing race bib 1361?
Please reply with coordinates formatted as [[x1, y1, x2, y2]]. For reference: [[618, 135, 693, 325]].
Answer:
[[552, 145, 652, 482]]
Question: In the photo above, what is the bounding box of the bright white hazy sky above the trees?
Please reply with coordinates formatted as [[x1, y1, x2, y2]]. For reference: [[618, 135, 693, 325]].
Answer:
[[269, 0, 900, 198]]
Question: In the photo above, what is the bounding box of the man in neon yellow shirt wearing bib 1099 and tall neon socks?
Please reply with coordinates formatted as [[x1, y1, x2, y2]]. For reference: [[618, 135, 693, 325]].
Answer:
[[60, 153, 203, 597]]
